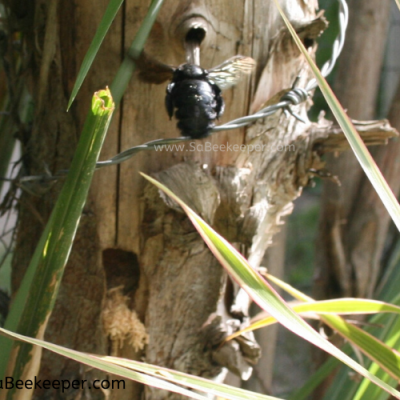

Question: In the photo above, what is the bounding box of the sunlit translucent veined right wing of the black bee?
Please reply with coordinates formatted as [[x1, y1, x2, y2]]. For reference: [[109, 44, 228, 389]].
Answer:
[[208, 56, 256, 90]]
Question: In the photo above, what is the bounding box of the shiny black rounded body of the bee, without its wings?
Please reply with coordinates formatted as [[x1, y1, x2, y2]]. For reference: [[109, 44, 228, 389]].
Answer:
[[166, 79, 222, 138]]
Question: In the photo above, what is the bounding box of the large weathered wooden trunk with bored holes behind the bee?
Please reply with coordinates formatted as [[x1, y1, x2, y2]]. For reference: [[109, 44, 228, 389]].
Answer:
[[9, 0, 396, 400]]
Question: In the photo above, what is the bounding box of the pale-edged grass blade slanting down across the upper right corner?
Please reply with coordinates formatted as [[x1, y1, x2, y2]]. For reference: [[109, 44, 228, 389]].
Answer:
[[274, 0, 400, 231]]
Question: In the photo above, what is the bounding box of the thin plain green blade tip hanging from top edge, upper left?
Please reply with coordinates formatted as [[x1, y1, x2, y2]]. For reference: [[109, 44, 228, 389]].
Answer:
[[67, 0, 124, 110]]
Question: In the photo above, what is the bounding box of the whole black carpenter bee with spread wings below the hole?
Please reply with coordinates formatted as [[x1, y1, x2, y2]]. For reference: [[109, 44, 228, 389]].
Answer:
[[135, 53, 255, 139]]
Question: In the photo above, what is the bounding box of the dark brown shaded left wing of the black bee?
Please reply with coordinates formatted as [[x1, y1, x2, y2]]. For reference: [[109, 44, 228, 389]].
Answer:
[[129, 51, 175, 84]]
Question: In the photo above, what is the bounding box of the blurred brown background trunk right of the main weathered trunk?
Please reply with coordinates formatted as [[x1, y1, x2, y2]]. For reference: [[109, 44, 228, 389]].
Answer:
[[315, 0, 396, 298]]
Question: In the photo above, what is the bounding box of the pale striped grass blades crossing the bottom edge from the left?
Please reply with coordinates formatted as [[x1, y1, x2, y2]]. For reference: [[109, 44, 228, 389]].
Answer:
[[0, 328, 281, 400]]
